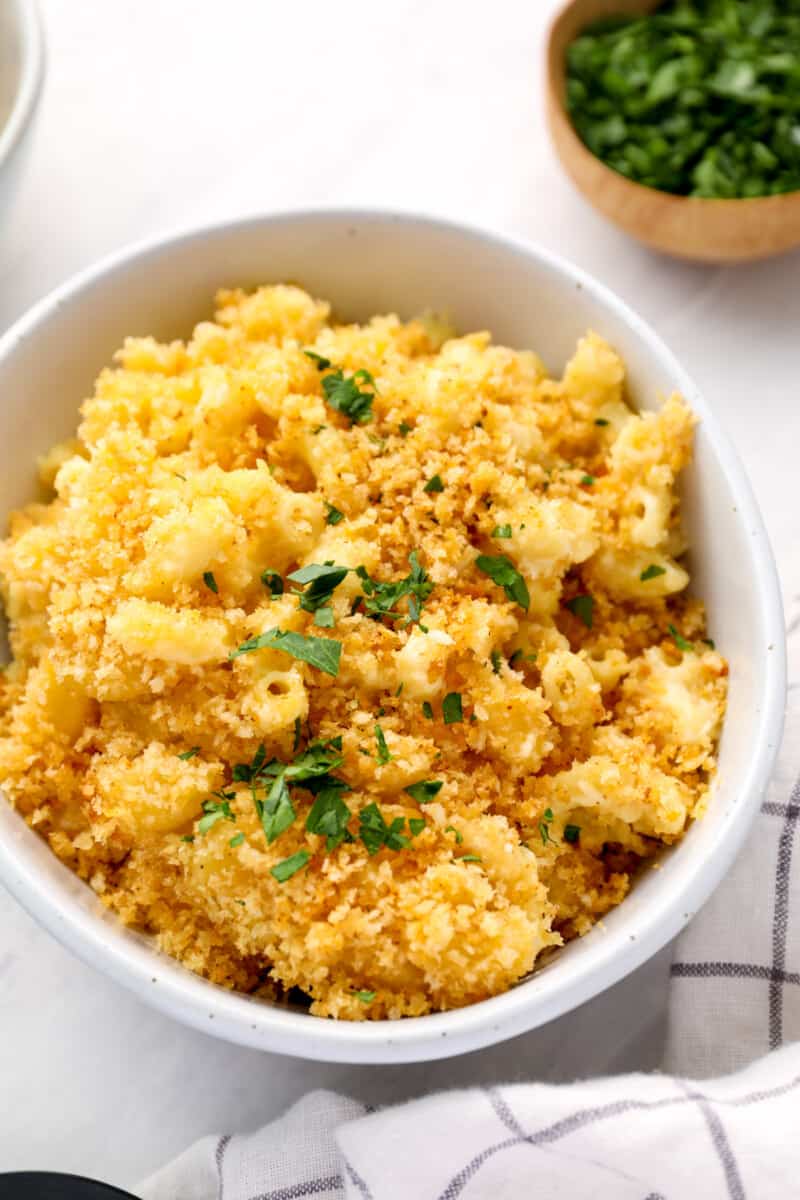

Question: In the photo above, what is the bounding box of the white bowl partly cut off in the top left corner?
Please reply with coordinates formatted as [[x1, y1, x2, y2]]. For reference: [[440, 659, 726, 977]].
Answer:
[[0, 0, 44, 168]]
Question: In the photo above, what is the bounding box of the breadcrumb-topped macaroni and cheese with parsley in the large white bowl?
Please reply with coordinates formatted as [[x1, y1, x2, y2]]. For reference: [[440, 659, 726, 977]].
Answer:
[[0, 286, 727, 1020]]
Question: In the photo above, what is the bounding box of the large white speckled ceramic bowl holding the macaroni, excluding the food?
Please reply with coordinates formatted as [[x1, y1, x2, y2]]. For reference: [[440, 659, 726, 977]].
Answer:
[[0, 212, 784, 1062]]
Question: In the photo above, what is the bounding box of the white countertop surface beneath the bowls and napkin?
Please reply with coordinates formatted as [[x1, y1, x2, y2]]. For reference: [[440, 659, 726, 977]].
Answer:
[[0, 0, 800, 1187]]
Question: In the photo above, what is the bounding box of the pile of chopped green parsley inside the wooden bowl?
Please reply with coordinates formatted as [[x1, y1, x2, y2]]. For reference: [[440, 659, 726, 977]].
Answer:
[[565, 0, 800, 199]]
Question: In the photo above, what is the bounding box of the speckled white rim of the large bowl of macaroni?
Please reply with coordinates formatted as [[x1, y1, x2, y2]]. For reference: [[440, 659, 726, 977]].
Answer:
[[0, 208, 786, 1063]]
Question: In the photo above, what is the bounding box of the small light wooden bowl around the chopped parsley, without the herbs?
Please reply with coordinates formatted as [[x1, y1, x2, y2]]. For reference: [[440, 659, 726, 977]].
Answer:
[[546, 0, 800, 263]]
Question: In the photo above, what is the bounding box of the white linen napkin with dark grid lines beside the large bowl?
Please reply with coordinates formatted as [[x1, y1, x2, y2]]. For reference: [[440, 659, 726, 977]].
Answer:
[[139, 616, 800, 1200]]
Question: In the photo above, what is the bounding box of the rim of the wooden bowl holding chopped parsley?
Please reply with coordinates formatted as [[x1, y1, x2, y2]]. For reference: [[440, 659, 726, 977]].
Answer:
[[543, 0, 800, 208]]
